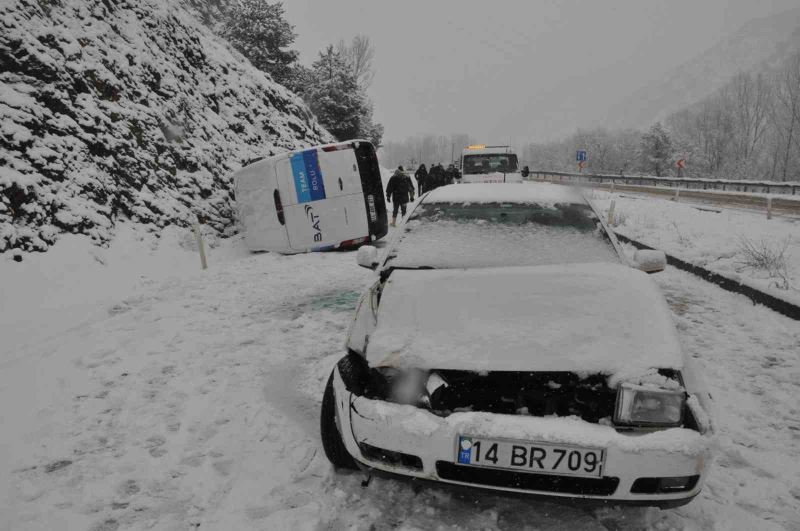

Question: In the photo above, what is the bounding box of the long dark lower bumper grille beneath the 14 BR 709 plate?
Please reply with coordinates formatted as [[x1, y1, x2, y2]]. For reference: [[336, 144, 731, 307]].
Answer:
[[436, 461, 619, 496]]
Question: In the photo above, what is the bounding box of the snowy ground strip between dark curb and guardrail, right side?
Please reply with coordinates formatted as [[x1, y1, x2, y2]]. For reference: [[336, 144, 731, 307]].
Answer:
[[591, 191, 800, 304]]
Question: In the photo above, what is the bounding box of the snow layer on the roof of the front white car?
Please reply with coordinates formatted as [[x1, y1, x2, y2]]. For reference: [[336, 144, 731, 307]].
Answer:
[[423, 183, 586, 204]]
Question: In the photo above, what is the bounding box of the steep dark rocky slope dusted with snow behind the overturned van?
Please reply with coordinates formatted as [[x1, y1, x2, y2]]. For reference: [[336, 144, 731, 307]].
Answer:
[[0, 0, 332, 252]]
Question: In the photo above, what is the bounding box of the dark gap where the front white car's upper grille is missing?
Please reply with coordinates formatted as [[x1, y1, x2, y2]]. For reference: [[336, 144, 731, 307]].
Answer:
[[430, 370, 617, 423]]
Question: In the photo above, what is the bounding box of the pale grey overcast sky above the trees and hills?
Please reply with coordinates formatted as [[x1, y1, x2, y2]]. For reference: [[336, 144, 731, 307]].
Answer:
[[284, 0, 797, 143]]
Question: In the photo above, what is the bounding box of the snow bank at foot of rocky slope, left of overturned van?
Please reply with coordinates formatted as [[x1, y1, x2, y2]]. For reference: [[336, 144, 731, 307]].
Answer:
[[0, 223, 248, 356]]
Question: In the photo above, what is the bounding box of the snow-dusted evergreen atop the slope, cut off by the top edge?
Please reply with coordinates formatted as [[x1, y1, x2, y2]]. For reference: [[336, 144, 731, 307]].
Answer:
[[222, 0, 298, 84]]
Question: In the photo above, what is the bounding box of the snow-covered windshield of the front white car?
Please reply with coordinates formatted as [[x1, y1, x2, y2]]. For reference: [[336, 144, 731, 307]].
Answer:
[[387, 203, 620, 269]]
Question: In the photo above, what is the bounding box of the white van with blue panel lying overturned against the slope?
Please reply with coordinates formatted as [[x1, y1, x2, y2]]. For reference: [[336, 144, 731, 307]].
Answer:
[[233, 140, 388, 253]]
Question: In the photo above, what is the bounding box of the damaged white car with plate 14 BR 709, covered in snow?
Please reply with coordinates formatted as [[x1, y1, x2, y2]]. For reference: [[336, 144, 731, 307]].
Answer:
[[321, 183, 714, 507]]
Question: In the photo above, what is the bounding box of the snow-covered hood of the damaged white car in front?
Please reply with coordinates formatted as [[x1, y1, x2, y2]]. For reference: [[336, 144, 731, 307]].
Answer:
[[367, 263, 683, 376]]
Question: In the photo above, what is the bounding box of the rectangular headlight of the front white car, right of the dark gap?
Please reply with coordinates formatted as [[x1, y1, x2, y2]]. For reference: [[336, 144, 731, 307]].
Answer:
[[614, 383, 686, 427]]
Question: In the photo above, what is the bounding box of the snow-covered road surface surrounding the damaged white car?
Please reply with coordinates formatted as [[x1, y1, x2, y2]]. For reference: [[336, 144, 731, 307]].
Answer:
[[0, 239, 800, 531]]
